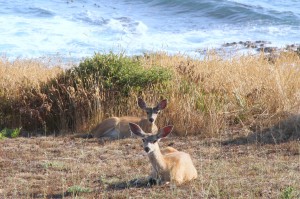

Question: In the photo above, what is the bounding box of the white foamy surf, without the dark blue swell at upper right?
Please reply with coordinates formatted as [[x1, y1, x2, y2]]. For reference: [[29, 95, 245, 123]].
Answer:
[[0, 0, 300, 58]]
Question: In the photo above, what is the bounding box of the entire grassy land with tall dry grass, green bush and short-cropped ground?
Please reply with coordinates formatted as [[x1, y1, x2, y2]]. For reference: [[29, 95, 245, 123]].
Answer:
[[0, 52, 300, 199]]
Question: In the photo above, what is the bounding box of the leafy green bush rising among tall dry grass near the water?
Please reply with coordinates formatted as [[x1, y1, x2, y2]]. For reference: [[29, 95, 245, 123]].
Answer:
[[68, 53, 172, 95]]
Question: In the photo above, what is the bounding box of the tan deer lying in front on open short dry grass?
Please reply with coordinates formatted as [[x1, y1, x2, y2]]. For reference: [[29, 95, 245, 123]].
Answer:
[[129, 123, 197, 185]]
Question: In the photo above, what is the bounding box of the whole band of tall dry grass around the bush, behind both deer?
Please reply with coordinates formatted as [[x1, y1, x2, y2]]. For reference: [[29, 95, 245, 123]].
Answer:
[[0, 52, 300, 136]]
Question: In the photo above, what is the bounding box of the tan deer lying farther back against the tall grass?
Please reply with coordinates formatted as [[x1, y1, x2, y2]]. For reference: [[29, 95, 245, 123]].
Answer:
[[91, 98, 167, 139]]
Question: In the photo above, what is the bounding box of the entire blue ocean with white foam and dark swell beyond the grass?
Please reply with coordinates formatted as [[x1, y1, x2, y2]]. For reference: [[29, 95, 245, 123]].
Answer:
[[0, 0, 300, 59]]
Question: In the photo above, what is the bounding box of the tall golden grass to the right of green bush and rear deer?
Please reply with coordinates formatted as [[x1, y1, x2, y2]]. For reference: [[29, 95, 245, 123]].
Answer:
[[145, 53, 300, 138]]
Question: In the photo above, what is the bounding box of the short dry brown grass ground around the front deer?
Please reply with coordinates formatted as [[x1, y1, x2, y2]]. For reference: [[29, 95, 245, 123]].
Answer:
[[0, 134, 300, 198]]
